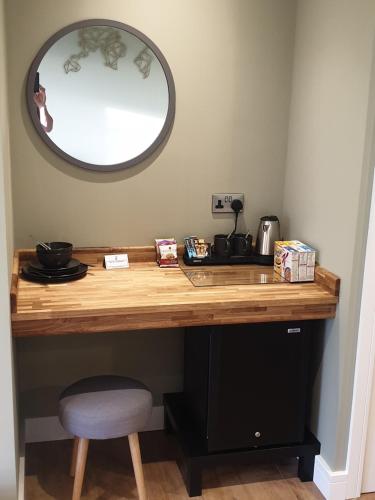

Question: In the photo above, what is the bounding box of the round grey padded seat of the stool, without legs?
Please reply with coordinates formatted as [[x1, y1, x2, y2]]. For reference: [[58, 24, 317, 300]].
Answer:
[[59, 375, 152, 439]]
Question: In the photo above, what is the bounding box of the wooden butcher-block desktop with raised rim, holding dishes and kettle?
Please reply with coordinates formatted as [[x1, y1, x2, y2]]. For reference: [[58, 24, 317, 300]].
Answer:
[[11, 247, 340, 337]]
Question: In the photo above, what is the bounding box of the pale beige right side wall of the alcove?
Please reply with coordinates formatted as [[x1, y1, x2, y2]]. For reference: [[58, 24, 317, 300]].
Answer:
[[284, 0, 375, 470]]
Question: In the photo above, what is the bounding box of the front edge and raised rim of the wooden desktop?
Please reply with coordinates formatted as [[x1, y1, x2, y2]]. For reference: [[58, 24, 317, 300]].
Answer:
[[10, 245, 340, 336]]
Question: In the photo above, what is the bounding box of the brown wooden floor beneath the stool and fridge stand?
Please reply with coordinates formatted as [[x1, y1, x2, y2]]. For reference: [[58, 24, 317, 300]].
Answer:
[[25, 432, 326, 500]]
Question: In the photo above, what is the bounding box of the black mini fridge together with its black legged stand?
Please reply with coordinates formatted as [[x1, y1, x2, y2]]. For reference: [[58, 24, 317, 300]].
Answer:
[[164, 321, 320, 496]]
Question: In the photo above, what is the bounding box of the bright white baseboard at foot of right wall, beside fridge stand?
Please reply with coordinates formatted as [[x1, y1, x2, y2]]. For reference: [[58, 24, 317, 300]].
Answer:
[[314, 455, 348, 500]]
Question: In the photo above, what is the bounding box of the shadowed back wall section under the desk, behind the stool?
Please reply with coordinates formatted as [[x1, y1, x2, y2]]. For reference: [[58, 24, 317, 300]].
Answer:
[[17, 329, 183, 417]]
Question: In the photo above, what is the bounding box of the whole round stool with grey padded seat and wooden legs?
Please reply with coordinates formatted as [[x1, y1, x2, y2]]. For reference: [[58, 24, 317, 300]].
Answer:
[[59, 375, 152, 500]]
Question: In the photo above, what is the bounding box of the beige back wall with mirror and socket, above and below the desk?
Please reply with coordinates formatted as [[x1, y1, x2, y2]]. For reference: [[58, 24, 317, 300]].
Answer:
[[7, 0, 295, 422]]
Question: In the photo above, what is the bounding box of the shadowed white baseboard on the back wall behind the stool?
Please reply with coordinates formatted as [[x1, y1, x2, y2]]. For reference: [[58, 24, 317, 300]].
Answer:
[[25, 406, 164, 443]]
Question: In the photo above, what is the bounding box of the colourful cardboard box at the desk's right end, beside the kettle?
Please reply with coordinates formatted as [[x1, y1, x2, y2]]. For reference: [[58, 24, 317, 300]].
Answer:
[[274, 240, 316, 282]]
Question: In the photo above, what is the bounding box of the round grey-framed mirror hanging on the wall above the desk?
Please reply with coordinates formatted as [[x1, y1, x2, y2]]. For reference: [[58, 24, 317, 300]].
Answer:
[[27, 19, 175, 171]]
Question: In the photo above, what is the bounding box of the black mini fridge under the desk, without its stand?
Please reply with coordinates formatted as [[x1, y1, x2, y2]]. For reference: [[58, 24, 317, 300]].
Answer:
[[184, 321, 311, 453]]
